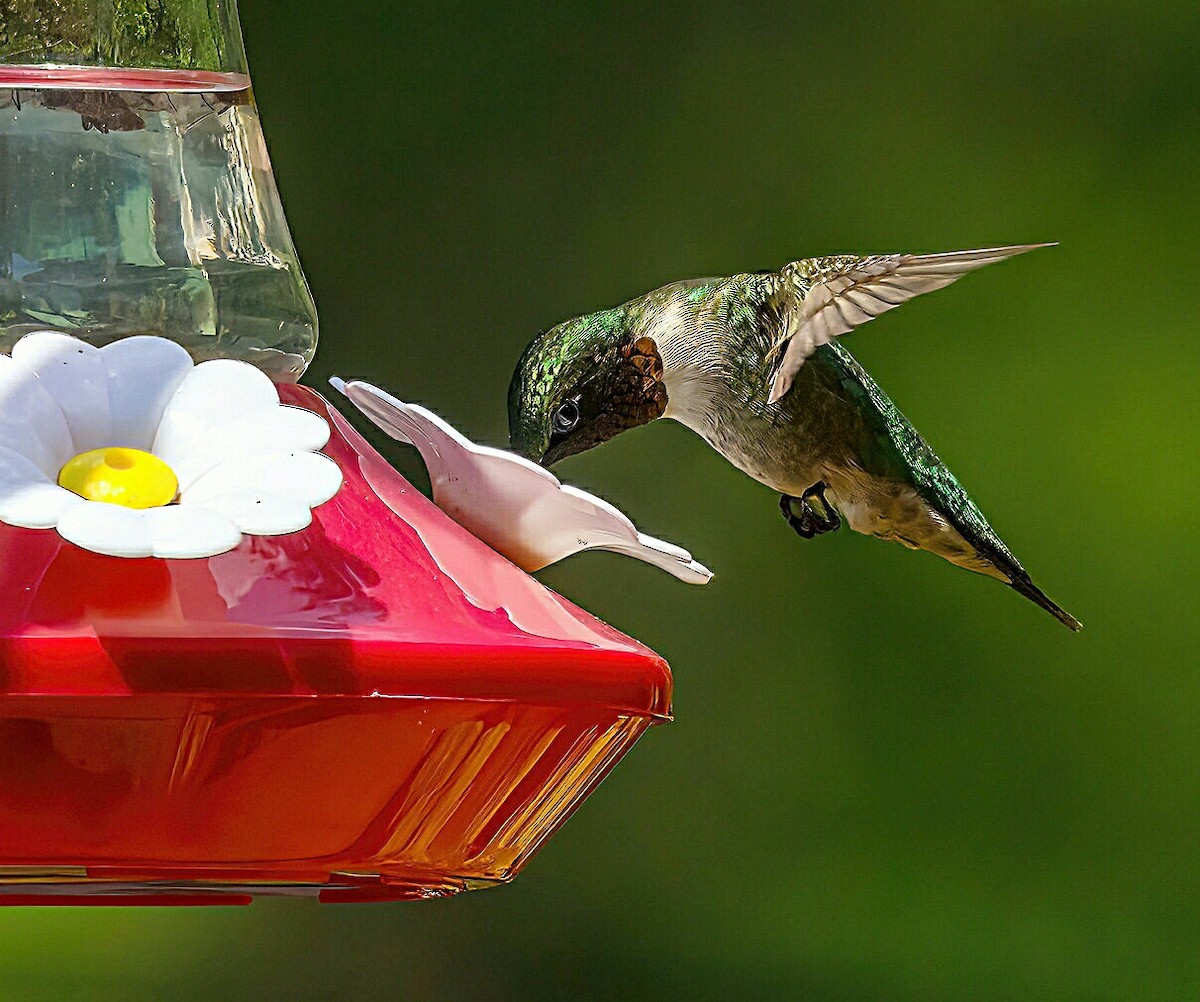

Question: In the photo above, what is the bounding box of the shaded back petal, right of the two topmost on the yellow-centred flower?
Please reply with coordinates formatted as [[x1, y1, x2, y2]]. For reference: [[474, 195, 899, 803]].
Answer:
[[102, 335, 192, 451]]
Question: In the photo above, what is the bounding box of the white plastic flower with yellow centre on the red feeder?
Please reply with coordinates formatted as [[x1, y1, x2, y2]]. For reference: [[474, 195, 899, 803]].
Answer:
[[0, 331, 342, 558]]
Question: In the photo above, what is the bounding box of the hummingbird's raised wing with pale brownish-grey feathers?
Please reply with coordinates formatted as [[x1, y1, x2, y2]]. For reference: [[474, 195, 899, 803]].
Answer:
[[767, 244, 1052, 403]]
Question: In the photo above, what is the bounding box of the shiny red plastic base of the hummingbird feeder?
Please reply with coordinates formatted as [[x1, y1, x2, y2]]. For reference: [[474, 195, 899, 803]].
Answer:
[[0, 386, 671, 905]]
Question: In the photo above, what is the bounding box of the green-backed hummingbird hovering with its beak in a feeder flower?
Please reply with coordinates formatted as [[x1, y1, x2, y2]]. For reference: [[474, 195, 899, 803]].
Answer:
[[509, 244, 1082, 630]]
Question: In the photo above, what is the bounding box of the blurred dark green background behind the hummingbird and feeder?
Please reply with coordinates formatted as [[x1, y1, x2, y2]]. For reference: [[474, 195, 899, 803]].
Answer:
[[9, 0, 1200, 1000]]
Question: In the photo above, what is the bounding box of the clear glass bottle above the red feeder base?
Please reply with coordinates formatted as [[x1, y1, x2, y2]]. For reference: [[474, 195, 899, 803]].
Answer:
[[0, 0, 317, 382]]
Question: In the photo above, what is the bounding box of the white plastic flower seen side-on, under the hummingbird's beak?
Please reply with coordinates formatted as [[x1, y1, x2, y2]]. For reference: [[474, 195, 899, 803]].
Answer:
[[330, 379, 713, 584]]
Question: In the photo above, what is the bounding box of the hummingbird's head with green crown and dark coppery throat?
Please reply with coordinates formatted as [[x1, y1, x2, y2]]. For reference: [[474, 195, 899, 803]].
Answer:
[[509, 307, 667, 467]]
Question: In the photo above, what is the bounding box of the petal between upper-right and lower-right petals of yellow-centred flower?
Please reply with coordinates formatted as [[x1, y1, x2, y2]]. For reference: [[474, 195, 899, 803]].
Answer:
[[154, 404, 329, 491]]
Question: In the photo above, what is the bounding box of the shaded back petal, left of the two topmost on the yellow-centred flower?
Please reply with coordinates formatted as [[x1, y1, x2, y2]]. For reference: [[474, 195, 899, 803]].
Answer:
[[12, 330, 112, 452]]
